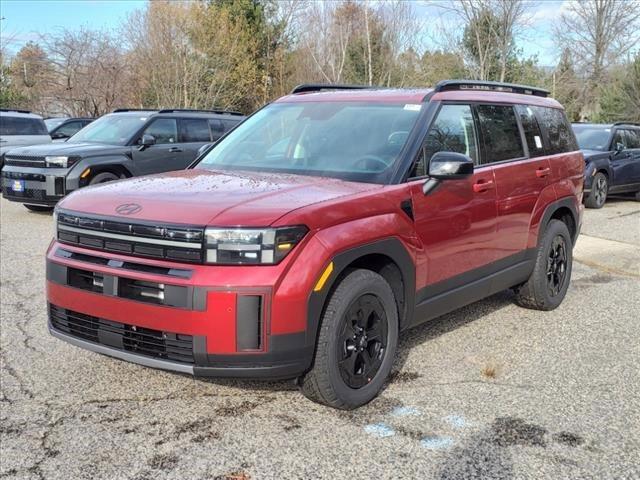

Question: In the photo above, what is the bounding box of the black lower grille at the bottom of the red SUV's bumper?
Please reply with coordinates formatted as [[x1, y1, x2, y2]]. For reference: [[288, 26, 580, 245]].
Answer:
[[49, 304, 194, 363]]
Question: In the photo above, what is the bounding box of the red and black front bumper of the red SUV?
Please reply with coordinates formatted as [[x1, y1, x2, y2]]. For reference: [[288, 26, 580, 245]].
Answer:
[[47, 242, 314, 379]]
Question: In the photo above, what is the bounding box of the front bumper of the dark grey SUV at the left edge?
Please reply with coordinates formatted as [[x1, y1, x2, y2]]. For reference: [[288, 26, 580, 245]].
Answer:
[[1, 165, 69, 207]]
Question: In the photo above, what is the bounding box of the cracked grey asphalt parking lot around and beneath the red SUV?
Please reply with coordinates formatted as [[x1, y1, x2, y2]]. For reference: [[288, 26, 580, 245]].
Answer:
[[0, 199, 640, 480]]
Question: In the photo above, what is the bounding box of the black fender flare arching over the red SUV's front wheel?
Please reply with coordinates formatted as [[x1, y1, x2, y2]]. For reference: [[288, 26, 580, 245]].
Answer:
[[305, 237, 416, 353]]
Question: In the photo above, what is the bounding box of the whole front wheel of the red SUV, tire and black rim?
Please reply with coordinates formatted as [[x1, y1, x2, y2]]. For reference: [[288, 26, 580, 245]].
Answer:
[[301, 270, 398, 410]]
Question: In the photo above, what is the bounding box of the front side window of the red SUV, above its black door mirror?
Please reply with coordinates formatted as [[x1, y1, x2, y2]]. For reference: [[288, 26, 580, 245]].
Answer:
[[409, 105, 478, 177]]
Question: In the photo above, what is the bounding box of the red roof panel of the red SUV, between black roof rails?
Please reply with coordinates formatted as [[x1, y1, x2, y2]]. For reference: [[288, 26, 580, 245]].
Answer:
[[275, 88, 562, 108]]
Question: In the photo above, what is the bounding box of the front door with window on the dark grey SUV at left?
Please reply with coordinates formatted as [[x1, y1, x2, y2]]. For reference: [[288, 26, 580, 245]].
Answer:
[[132, 118, 184, 175]]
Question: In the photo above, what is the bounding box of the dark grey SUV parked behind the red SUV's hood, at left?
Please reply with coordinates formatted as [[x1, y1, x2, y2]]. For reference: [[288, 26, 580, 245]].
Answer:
[[2, 109, 244, 211]]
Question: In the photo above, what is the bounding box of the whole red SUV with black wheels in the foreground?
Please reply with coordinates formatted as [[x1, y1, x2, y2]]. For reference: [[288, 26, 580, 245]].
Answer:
[[47, 81, 584, 408]]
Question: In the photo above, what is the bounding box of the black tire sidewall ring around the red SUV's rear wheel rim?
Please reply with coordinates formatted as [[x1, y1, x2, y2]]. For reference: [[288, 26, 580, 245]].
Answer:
[[536, 220, 573, 310]]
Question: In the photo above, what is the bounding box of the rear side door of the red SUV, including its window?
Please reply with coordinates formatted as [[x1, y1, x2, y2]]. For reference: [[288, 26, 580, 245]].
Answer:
[[476, 105, 552, 258]]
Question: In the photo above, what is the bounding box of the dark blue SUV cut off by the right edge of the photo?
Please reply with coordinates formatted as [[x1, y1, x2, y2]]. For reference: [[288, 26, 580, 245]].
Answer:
[[573, 122, 640, 208]]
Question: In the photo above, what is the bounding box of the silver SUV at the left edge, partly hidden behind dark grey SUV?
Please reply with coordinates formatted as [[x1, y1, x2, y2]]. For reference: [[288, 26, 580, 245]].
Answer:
[[0, 109, 51, 168]]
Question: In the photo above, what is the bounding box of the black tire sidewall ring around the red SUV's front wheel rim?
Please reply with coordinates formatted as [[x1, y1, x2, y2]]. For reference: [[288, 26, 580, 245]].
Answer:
[[326, 274, 398, 406]]
